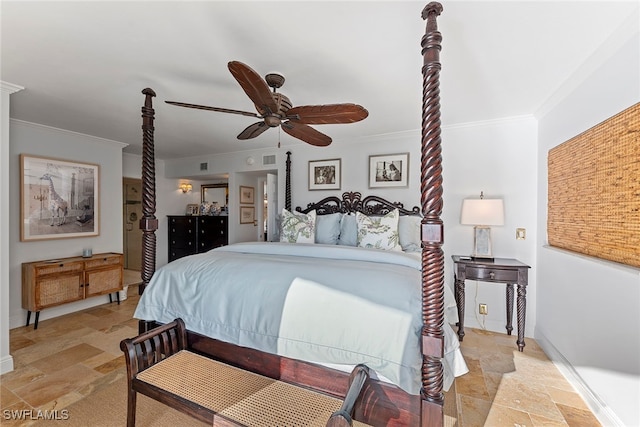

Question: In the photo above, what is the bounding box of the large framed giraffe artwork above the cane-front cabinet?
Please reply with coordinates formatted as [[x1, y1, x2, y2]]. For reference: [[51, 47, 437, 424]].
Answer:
[[20, 154, 100, 242]]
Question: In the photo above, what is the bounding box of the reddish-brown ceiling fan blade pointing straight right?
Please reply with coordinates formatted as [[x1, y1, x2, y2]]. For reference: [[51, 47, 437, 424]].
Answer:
[[287, 104, 369, 125]]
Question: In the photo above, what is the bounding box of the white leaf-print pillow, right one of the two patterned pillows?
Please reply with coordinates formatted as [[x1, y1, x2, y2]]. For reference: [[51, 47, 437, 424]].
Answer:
[[356, 209, 402, 251]]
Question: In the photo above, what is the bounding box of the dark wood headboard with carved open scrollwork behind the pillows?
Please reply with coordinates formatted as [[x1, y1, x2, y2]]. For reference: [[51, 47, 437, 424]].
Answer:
[[296, 191, 420, 215]]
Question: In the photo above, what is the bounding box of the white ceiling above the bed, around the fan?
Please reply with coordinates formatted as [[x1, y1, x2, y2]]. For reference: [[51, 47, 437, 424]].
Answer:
[[0, 0, 639, 158]]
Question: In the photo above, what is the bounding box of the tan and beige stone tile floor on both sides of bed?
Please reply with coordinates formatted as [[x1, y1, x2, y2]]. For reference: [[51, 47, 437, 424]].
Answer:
[[0, 276, 600, 427]]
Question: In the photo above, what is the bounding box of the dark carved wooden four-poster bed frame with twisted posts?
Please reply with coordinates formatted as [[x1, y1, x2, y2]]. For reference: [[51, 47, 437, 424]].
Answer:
[[131, 2, 445, 426]]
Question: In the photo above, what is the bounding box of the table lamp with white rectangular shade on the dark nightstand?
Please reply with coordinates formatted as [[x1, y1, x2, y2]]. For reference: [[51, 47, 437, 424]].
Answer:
[[460, 192, 504, 261]]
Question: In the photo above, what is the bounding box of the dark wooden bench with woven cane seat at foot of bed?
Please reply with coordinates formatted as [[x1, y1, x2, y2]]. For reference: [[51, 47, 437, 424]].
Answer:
[[120, 319, 369, 427]]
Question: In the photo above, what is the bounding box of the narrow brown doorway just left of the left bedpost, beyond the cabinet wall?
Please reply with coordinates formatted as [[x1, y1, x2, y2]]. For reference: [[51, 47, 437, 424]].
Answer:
[[122, 178, 142, 271]]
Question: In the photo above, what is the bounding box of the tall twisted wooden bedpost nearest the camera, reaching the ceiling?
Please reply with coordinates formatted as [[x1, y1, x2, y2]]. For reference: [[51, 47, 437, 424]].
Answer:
[[420, 2, 444, 427]]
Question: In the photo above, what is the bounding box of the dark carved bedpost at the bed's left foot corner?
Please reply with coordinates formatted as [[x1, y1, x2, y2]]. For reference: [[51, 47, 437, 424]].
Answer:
[[138, 88, 158, 295]]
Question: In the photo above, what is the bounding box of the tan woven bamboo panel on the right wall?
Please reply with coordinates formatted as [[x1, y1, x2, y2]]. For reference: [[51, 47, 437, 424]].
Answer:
[[547, 103, 640, 267]]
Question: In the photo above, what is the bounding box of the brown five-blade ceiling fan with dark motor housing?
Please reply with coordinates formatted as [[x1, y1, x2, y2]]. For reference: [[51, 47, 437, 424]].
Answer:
[[165, 61, 369, 147]]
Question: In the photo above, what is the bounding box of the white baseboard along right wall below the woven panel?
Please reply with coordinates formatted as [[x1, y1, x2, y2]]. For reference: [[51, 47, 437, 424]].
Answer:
[[535, 329, 625, 427]]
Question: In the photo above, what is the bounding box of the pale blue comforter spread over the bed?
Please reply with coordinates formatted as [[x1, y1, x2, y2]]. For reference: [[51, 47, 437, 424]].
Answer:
[[134, 243, 467, 394]]
